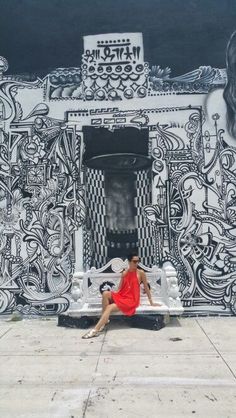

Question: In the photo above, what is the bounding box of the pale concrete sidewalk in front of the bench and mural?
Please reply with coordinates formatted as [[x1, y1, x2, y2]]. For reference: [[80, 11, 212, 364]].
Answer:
[[0, 317, 236, 418]]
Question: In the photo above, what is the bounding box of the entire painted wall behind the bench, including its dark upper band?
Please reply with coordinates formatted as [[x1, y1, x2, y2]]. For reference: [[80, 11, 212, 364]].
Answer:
[[0, 0, 236, 315]]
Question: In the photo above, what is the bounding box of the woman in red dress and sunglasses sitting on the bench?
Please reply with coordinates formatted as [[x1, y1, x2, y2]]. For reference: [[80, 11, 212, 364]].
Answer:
[[82, 253, 161, 339]]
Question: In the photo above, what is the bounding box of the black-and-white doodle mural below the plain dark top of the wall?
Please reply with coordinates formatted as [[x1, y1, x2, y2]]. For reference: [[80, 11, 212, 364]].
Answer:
[[0, 33, 236, 315]]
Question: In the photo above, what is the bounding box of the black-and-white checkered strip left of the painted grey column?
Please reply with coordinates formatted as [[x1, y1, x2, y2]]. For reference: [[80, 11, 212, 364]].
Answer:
[[86, 168, 107, 268]]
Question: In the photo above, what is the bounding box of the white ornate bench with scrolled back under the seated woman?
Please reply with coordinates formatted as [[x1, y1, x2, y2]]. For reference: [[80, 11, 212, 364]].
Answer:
[[66, 258, 184, 317]]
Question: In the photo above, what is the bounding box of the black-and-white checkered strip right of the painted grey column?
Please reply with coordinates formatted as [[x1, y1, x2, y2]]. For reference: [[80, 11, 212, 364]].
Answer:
[[135, 171, 154, 267]]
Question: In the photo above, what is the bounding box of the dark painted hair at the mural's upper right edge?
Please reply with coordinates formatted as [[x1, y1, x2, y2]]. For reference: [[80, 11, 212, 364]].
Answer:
[[223, 32, 236, 138]]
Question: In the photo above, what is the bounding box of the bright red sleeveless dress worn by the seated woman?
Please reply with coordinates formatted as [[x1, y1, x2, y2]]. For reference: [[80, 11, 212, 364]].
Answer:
[[111, 271, 140, 316]]
